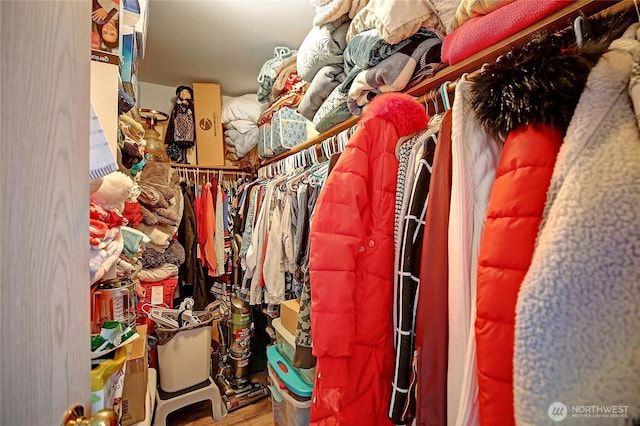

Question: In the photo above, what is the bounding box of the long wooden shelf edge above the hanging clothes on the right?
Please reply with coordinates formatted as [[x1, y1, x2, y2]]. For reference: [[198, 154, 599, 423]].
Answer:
[[260, 0, 633, 167]]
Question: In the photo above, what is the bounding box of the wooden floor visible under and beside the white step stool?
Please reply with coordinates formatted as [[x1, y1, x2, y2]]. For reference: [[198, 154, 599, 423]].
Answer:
[[167, 396, 274, 426]]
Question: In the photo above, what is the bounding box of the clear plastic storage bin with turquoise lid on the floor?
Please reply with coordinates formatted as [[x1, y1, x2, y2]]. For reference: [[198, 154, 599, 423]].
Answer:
[[267, 346, 313, 426]]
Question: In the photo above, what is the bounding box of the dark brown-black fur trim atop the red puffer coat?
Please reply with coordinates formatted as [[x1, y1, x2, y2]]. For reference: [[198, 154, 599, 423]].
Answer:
[[471, 9, 637, 139]]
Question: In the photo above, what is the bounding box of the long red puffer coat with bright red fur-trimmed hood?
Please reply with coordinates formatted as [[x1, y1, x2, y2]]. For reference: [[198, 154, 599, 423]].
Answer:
[[309, 93, 428, 426]]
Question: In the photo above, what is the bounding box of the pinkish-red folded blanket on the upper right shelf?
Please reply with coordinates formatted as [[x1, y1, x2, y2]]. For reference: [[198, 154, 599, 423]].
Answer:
[[442, 0, 567, 65]]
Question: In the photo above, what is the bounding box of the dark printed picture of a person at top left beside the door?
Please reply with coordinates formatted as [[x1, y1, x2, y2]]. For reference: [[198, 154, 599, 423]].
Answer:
[[91, 0, 121, 65]]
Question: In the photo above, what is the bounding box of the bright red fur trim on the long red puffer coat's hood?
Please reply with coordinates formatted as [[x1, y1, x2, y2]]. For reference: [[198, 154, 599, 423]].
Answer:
[[362, 92, 429, 136]]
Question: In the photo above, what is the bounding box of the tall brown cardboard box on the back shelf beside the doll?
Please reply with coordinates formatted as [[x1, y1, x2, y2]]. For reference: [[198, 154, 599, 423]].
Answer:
[[193, 83, 224, 166]]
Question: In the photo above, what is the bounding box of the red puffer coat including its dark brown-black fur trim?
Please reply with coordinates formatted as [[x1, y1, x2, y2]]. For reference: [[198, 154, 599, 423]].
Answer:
[[464, 12, 636, 426]]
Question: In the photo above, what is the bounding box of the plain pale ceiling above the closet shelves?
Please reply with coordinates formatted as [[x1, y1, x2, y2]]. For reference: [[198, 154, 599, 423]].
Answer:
[[138, 0, 315, 96]]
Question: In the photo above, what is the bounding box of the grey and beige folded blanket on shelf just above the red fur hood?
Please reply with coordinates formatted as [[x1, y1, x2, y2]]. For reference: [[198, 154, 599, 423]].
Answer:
[[348, 37, 443, 115]]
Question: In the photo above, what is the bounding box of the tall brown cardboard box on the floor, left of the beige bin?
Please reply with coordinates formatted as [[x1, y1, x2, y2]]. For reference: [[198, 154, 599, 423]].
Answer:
[[121, 325, 148, 426]]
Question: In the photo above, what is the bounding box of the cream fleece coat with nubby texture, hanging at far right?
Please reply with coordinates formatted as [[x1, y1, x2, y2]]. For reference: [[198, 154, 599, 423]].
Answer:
[[514, 26, 640, 425]]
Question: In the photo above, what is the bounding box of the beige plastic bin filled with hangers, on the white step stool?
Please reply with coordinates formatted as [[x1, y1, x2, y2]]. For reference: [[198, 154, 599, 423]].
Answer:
[[155, 312, 213, 392]]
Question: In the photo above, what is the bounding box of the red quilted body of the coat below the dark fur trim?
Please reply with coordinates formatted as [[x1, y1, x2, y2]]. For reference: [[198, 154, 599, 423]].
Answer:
[[476, 124, 563, 426]]
